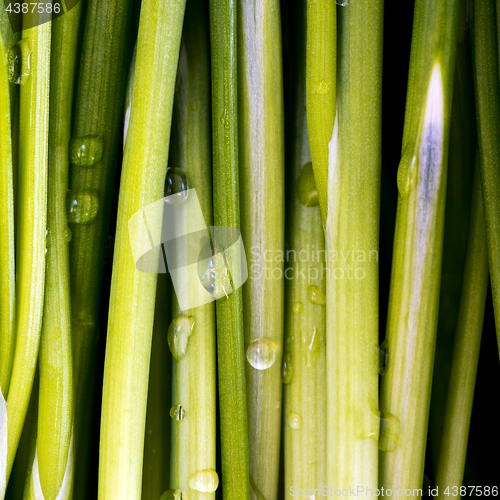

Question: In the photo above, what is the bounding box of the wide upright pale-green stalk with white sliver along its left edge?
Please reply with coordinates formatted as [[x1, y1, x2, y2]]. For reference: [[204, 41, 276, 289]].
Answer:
[[326, 0, 384, 488]]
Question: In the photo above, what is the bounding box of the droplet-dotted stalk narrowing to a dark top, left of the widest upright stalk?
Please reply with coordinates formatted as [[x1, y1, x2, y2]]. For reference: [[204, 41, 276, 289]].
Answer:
[[282, 2, 326, 492]]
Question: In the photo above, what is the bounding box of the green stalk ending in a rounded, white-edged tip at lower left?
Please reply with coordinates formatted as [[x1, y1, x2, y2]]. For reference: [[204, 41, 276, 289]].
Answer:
[[25, 4, 81, 500]]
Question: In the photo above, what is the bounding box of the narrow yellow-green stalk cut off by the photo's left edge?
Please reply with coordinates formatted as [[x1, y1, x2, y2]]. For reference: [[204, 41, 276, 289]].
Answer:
[[0, 33, 16, 399]]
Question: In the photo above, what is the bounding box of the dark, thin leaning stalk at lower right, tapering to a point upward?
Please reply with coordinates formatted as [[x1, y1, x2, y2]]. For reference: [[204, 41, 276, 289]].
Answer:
[[436, 159, 488, 492]]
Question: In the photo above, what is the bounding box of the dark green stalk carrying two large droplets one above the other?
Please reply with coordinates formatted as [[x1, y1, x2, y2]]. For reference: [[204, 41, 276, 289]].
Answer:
[[65, 0, 133, 464]]
